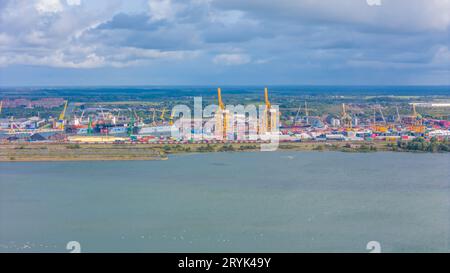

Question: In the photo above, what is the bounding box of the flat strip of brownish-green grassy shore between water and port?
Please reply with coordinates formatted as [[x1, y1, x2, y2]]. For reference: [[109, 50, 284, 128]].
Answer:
[[0, 141, 399, 162]]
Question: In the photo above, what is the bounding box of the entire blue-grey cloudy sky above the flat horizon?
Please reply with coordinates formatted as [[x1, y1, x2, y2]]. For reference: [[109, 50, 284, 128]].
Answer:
[[0, 0, 450, 85]]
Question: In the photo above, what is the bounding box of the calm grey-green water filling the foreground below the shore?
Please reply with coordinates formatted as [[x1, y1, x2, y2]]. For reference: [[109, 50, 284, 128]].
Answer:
[[0, 152, 450, 252]]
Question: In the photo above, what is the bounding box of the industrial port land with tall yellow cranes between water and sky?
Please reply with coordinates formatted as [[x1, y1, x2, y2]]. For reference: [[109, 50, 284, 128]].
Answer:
[[0, 87, 450, 157]]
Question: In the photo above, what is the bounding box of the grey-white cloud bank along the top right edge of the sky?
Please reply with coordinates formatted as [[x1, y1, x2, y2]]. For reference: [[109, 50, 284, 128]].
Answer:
[[213, 0, 450, 32]]
